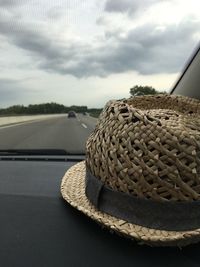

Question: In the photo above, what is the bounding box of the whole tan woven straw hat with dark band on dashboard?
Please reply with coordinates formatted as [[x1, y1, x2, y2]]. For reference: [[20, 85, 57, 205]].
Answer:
[[61, 95, 200, 246]]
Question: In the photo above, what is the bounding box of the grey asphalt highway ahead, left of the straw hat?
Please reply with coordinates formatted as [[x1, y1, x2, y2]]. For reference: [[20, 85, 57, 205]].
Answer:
[[0, 114, 96, 153]]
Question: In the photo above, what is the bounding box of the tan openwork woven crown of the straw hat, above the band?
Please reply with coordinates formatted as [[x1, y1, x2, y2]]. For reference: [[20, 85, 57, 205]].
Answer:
[[86, 95, 200, 201]]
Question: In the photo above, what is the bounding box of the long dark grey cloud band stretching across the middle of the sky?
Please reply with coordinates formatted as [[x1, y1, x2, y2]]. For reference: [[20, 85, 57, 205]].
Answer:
[[0, 8, 200, 78]]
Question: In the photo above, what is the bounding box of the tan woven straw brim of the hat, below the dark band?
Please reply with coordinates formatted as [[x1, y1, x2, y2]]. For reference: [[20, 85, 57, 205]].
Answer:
[[61, 161, 200, 247]]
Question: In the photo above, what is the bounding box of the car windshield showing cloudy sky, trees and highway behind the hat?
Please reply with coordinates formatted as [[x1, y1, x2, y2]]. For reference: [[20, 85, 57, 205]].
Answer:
[[0, 0, 200, 154]]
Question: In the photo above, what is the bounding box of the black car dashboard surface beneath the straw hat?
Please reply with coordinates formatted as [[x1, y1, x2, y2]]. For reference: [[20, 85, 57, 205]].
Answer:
[[0, 157, 200, 267]]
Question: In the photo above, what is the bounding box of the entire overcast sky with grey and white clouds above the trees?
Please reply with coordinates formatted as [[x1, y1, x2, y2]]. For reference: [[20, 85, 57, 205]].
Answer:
[[0, 0, 200, 107]]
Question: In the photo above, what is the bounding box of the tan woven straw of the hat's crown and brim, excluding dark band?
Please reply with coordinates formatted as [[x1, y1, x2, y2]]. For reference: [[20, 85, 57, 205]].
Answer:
[[61, 95, 200, 246]]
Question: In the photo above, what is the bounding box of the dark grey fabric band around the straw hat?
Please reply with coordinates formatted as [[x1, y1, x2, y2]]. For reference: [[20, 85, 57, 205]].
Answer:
[[85, 167, 200, 231]]
